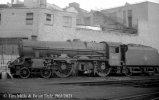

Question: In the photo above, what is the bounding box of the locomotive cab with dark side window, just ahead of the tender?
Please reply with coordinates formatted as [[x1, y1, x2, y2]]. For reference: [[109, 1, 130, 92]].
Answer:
[[108, 42, 130, 75]]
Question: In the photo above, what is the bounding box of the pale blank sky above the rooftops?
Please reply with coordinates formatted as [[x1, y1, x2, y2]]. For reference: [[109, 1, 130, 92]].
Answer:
[[0, 0, 159, 11]]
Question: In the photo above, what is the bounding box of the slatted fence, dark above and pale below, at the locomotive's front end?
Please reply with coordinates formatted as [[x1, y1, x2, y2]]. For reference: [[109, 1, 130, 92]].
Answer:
[[0, 38, 19, 72]]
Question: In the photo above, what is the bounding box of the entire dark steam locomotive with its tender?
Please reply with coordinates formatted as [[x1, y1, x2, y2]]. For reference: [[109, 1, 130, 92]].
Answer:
[[9, 40, 159, 78]]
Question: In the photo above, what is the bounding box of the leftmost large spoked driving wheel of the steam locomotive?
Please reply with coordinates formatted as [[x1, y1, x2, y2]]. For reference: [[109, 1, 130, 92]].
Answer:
[[55, 62, 72, 77]]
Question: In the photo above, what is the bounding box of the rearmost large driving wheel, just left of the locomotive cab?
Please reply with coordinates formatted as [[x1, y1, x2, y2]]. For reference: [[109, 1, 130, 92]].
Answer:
[[96, 62, 111, 77]]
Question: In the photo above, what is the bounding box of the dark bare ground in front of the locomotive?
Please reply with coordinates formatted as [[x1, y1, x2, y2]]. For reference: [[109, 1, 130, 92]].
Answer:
[[0, 75, 159, 100]]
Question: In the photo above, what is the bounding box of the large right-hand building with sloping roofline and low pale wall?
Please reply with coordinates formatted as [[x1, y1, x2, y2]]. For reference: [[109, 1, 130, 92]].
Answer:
[[74, 2, 159, 50]]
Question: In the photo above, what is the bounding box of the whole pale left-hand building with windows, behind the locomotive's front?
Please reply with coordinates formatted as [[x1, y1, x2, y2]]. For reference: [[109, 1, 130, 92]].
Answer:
[[0, 0, 76, 40]]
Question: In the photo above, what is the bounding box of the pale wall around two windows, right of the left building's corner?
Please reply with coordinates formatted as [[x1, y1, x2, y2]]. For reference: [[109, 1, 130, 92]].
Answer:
[[38, 9, 76, 41]]
